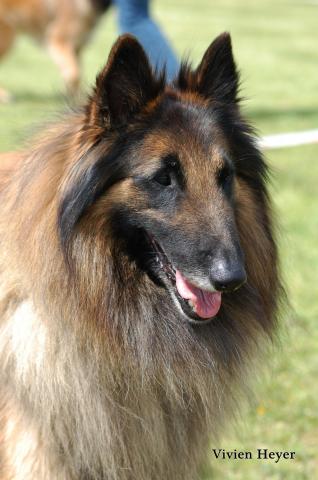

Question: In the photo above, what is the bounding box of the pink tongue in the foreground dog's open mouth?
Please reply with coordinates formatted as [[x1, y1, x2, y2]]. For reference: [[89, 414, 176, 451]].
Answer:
[[176, 270, 221, 318]]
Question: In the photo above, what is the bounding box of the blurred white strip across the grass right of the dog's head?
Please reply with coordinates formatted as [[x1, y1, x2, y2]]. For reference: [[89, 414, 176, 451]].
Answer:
[[259, 130, 318, 149]]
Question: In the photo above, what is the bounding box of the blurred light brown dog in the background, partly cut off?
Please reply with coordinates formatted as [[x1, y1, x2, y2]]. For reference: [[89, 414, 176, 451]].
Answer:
[[0, 0, 110, 102]]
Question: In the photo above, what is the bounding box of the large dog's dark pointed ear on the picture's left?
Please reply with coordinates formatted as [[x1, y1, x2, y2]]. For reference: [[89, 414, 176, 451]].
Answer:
[[89, 35, 164, 128]]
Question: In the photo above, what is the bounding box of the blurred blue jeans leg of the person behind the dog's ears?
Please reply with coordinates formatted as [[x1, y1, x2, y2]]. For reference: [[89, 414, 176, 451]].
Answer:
[[113, 0, 179, 81]]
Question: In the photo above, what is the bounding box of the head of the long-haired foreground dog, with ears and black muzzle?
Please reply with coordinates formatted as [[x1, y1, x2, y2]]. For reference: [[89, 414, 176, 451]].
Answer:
[[59, 34, 266, 323]]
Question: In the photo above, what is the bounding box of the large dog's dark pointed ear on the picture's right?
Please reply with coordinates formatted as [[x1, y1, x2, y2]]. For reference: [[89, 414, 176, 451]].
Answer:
[[195, 32, 239, 103]]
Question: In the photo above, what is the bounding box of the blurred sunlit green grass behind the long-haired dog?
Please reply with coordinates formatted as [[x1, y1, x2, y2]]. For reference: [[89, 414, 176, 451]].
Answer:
[[0, 0, 318, 480]]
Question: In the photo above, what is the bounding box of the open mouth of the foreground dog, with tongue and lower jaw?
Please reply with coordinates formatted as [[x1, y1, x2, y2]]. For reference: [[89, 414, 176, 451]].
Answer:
[[148, 235, 221, 323]]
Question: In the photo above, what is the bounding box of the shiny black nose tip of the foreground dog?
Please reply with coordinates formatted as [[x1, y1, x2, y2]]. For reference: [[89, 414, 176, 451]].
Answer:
[[210, 261, 246, 292]]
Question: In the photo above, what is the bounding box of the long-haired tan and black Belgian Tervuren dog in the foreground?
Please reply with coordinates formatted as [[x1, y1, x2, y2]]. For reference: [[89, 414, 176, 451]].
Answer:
[[0, 34, 279, 480]]
